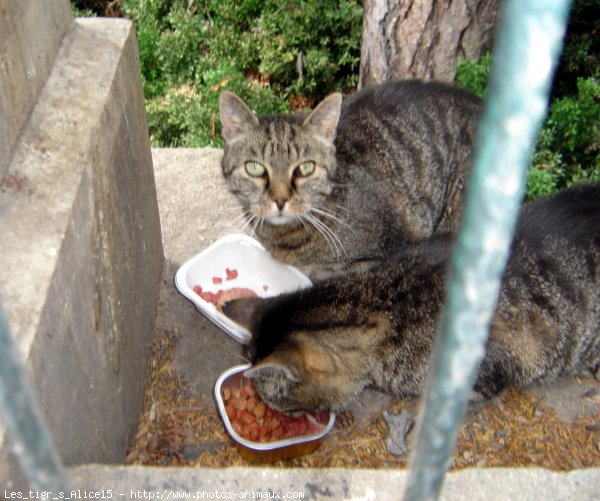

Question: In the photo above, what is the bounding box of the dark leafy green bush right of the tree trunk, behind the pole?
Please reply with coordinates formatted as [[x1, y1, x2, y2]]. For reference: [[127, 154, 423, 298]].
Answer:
[[456, 0, 600, 199]]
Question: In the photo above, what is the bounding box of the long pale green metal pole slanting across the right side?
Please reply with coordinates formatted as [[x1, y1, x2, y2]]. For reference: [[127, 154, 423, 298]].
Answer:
[[405, 0, 570, 501]]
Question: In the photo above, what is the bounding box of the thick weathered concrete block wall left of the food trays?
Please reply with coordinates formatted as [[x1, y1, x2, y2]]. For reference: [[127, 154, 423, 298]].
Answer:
[[0, 19, 164, 484]]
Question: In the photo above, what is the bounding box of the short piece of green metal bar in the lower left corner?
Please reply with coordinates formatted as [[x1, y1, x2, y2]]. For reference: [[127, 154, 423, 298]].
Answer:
[[0, 307, 67, 490]]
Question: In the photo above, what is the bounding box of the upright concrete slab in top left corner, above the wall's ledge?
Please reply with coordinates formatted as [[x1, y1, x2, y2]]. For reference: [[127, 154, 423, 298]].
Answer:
[[0, 0, 73, 179]]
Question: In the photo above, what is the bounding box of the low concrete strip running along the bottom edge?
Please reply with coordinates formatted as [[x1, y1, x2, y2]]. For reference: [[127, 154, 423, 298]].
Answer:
[[68, 465, 600, 501]]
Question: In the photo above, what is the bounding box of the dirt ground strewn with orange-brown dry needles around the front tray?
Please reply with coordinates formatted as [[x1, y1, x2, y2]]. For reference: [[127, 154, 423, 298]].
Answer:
[[125, 264, 600, 470]]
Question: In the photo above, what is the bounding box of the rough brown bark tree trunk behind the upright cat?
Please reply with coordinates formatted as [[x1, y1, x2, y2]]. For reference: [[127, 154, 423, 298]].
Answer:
[[360, 0, 500, 87]]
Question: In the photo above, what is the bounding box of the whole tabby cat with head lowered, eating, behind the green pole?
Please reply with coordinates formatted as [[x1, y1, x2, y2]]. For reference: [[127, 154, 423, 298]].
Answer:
[[224, 185, 600, 414]]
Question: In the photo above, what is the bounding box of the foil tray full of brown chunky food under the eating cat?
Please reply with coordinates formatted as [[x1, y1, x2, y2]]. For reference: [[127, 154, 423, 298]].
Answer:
[[215, 364, 335, 463]]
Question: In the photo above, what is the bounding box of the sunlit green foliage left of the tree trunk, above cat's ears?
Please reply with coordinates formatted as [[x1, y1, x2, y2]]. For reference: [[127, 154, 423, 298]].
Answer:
[[120, 0, 362, 146]]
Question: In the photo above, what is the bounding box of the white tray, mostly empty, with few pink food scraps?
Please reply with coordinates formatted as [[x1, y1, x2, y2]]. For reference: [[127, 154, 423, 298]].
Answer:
[[175, 234, 312, 344]]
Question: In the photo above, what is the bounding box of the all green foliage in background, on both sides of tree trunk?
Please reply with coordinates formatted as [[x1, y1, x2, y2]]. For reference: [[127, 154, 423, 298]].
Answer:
[[71, 0, 600, 203]]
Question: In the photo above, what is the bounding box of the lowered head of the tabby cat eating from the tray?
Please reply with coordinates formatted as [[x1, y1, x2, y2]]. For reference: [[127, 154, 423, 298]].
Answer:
[[223, 298, 366, 415]]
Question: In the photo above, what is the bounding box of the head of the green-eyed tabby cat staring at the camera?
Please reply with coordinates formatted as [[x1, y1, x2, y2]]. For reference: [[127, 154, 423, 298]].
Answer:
[[220, 91, 342, 225]]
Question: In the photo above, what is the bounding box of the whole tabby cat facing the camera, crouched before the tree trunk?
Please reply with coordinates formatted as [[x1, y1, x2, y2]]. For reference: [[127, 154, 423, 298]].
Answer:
[[220, 81, 481, 278]]
